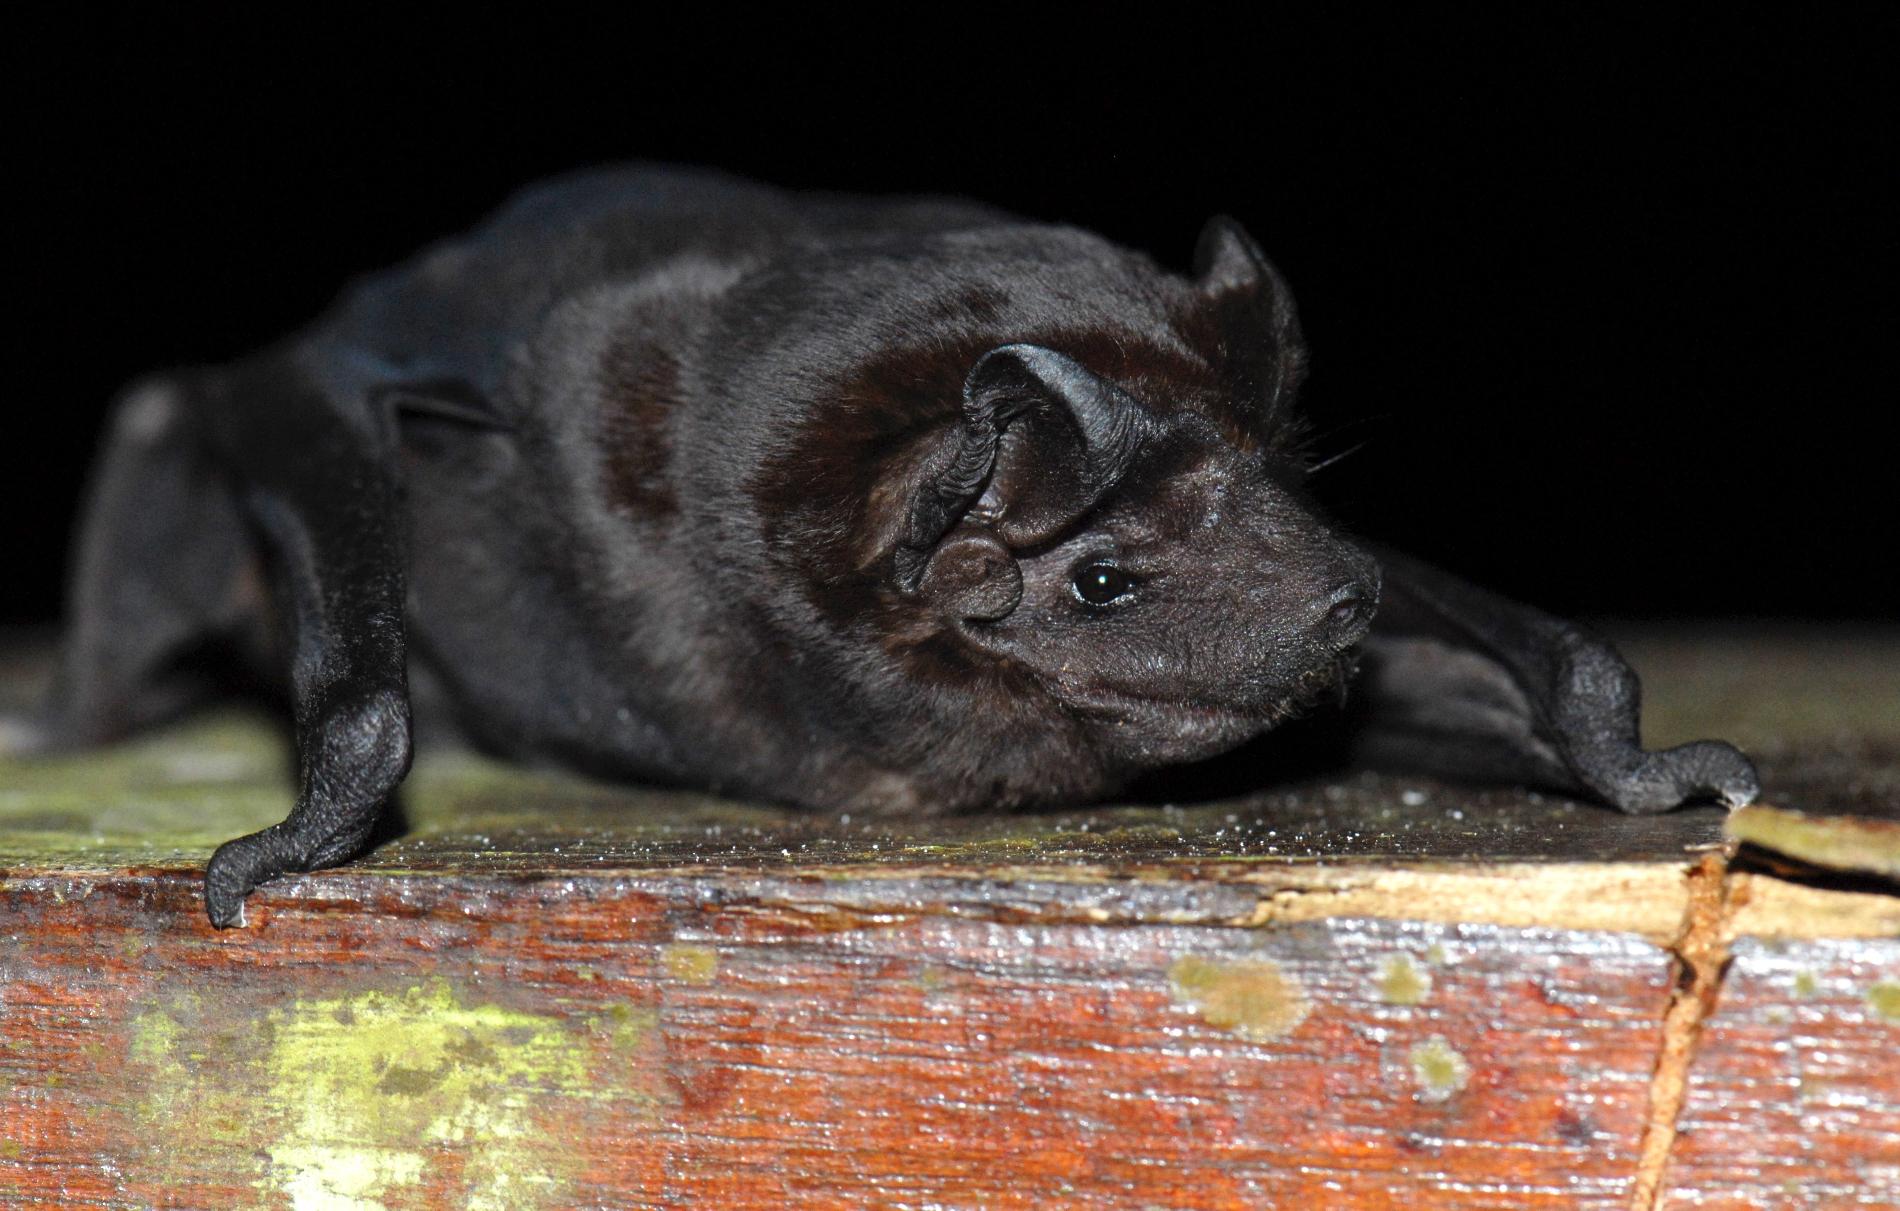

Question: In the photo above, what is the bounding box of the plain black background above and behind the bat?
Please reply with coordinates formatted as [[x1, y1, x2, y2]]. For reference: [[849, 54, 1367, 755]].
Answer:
[[0, 6, 1900, 622]]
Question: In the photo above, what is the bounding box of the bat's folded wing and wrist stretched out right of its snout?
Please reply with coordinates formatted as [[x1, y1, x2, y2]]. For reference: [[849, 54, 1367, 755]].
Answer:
[[1355, 551, 1759, 814]]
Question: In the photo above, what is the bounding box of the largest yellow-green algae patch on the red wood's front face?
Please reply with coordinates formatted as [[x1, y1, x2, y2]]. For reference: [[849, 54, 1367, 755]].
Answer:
[[127, 979, 657, 1211]]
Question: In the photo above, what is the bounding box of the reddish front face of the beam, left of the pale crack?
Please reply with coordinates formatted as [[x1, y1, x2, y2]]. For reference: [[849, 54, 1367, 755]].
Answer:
[[11, 863, 1668, 1207]]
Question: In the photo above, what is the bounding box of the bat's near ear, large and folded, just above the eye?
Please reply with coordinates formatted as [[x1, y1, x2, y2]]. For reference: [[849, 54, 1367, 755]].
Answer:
[[893, 344, 1159, 618]]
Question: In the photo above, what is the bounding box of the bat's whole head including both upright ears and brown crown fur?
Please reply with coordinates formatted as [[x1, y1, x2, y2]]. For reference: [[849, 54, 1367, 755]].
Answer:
[[756, 221, 1379, 768]]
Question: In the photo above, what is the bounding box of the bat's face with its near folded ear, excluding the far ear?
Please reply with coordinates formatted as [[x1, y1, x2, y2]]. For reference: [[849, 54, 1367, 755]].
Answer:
[[891, 357, 1379, 764]]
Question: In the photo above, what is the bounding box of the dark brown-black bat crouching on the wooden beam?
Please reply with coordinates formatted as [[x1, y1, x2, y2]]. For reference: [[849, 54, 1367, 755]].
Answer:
[[13, 165, 1758, 926]]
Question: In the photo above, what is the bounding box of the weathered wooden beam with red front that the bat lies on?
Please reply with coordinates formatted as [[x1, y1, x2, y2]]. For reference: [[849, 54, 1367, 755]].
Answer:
[[0, 635, 1900, 1207]]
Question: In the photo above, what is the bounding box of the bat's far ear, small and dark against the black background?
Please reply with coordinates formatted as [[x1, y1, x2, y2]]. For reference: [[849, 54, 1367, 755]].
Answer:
[[1193, 215, 1305, 409]]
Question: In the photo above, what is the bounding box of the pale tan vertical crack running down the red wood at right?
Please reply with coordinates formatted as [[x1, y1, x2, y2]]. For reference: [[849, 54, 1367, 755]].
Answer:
[[1630, 850, 1737, 1211]]
